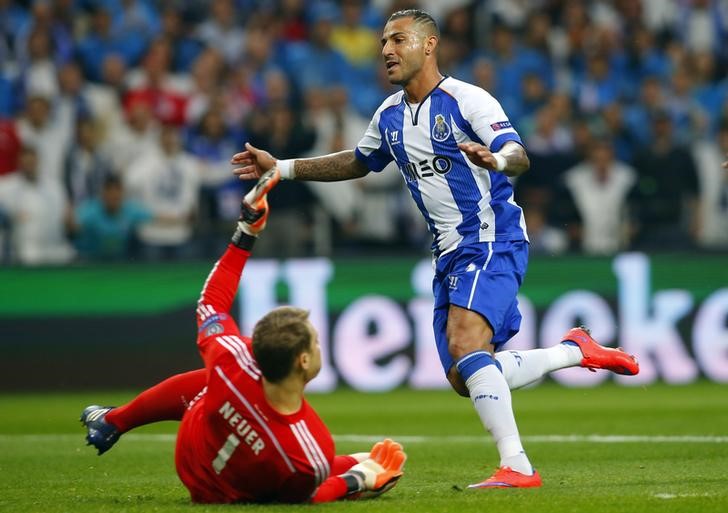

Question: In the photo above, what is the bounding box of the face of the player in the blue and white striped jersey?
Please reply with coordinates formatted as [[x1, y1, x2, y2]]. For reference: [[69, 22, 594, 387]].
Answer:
[[382, 18, 427, 86]]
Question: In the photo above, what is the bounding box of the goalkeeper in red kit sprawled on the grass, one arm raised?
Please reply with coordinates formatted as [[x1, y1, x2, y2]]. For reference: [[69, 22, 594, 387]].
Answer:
[[81, 169, 406, 503]]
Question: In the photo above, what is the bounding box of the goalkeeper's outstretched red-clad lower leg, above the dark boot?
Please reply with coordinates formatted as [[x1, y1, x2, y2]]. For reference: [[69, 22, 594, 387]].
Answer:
[[106, 369, 207, 433]]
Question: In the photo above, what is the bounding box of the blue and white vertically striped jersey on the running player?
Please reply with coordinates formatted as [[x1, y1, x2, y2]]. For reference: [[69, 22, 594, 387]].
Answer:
[[356, 77, 528, 256]]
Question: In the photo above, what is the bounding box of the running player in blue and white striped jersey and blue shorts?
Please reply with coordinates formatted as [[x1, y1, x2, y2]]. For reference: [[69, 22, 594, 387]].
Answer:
[[231, 9, 638, 488]]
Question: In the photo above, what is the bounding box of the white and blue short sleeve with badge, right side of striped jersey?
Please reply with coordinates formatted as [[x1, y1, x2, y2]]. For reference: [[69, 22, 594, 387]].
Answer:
[[461, 88, 523, 152]]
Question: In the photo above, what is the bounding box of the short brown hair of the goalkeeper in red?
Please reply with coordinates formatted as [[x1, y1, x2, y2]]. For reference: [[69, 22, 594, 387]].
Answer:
[[253, 306, 312, 383]]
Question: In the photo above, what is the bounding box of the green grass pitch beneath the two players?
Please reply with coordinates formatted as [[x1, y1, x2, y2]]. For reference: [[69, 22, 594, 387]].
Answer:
[[0, 382, 728, 513]]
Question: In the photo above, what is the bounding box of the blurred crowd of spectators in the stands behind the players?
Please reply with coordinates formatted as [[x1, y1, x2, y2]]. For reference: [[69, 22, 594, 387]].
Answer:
[[0, 0, 728, 265]]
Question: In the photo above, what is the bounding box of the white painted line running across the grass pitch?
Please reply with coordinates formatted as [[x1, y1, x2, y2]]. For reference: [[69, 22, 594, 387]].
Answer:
[[0, 432, 728, 444]]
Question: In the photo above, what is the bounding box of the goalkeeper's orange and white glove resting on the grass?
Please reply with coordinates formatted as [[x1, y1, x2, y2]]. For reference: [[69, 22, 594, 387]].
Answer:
[[341, 438, 407, 499]]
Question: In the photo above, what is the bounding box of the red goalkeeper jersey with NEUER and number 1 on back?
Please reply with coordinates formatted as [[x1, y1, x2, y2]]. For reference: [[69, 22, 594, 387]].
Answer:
[[175, 246, 334, 502]]
